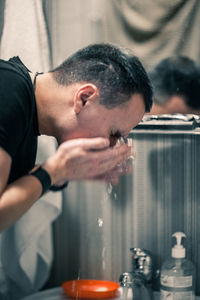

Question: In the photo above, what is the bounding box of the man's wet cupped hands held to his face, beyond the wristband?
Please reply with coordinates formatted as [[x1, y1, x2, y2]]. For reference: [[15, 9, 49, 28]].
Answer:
[[43, 138, 131, 185]]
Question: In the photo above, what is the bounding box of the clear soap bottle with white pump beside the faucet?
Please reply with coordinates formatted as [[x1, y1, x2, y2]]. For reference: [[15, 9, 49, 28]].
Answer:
[[160, 232, 195, 300]]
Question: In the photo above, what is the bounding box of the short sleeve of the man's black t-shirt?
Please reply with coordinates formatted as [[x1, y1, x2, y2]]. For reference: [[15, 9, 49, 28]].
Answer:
[[0, 69, 30, 158]]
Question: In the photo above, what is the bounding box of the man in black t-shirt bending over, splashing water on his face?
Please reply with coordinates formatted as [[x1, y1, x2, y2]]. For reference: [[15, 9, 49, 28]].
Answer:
[[0, 44, 152, 230]]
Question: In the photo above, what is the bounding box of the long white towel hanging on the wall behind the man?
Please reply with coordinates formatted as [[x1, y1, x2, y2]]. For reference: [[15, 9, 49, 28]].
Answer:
[[0, 0, 62, 300]]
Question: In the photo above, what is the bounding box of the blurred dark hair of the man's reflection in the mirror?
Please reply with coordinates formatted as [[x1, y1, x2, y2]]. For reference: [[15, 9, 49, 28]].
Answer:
[[149, 56, 200, 109]]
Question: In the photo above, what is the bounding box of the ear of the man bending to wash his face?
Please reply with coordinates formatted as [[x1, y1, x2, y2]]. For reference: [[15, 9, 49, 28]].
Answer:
[[74, 83, 99, 114]]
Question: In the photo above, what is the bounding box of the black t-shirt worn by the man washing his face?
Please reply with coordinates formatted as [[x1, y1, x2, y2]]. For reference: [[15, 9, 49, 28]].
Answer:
[[0, 57, 39, 183]]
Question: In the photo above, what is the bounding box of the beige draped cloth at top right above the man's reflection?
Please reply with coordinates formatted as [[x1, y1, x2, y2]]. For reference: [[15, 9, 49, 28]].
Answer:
[[105, 0, 200, 68]]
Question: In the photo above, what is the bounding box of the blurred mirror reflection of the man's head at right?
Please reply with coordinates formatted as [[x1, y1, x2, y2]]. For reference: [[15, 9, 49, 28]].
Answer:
[[150, 56, 200, 114]]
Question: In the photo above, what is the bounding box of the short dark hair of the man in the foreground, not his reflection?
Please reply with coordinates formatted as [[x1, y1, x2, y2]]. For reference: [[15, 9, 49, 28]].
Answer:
[[50, 43, 152, 111]]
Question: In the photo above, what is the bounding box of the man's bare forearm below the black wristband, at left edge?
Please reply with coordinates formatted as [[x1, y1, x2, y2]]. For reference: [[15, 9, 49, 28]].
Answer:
[[0, 175, 42, 231]]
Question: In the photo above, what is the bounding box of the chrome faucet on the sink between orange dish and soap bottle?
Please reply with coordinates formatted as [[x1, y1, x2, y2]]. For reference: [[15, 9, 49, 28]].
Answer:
[[119, 248, 153, 300]]
